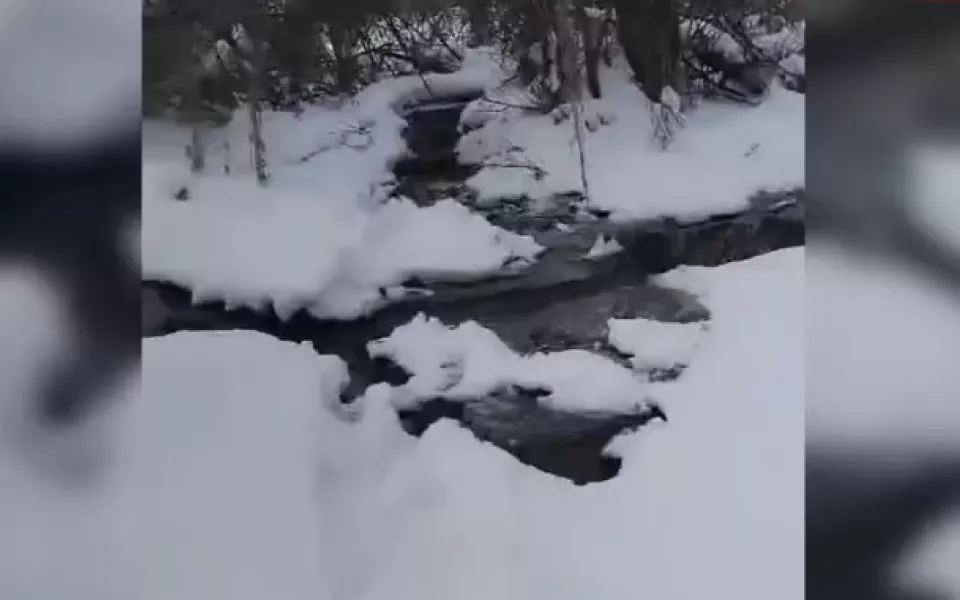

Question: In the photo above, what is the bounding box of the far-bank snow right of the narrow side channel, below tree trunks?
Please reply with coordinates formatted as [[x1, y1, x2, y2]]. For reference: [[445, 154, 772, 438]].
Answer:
[[458, 63, 804, 220]]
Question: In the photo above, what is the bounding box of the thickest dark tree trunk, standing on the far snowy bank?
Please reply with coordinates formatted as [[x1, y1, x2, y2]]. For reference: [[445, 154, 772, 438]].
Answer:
[[616, 0, 680, 102]]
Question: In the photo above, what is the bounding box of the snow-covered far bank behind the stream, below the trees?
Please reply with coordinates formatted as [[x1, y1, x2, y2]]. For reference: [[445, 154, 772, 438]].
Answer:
[[142, 25, 804, 318]]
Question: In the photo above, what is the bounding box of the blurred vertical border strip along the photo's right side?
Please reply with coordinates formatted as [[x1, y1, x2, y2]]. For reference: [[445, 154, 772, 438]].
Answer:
[[807, 1, 960, 600]]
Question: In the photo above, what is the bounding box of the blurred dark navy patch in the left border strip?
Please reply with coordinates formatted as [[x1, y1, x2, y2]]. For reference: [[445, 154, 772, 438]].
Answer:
[[0, 129, 141, 426]]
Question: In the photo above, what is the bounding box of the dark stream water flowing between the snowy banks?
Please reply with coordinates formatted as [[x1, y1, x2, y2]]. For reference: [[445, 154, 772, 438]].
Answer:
[[143, 98, 804, 484]]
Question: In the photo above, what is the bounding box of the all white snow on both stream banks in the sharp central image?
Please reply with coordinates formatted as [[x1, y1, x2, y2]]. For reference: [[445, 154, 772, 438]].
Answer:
[[133, 30, 804, 600]]
